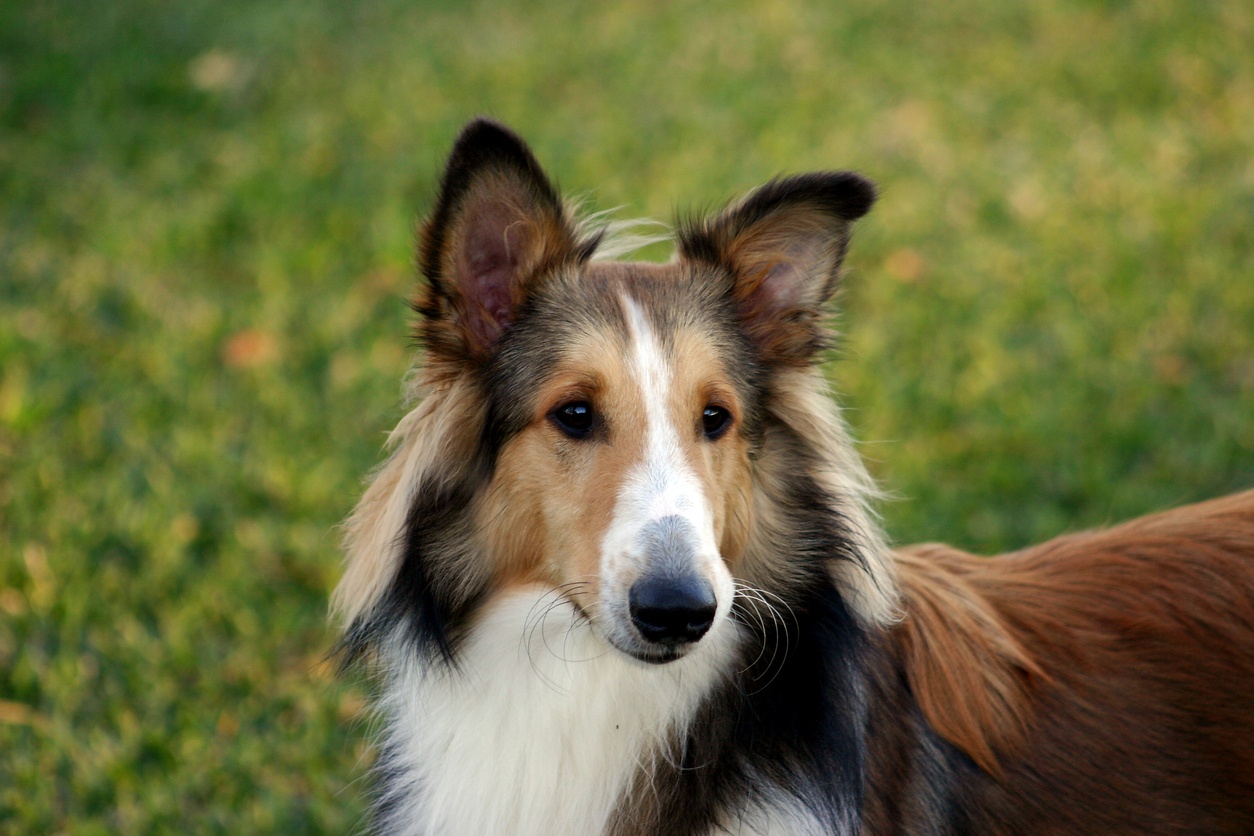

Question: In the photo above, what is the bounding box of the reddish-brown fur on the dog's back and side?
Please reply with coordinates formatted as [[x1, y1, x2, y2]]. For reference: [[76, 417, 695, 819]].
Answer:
[[867, 491, 1254, 833]]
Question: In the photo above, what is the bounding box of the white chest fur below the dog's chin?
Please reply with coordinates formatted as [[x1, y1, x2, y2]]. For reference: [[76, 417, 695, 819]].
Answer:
[[382, 589, 736, 836]]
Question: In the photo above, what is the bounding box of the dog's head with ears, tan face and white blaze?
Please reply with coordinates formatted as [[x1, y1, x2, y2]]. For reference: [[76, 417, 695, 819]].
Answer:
[[340, 120, 874, 662]]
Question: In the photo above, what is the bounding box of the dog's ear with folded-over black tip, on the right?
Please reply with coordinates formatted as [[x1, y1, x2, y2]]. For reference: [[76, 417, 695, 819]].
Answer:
[[678, 172, 875, 363]]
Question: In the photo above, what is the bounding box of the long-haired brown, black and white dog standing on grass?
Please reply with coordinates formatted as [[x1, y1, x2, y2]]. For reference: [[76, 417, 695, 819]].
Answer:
[[334, 120, 1254, 835]]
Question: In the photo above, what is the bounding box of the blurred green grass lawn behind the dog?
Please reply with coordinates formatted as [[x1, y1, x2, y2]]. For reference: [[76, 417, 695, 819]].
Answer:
[[0, 0, 1254, 833]]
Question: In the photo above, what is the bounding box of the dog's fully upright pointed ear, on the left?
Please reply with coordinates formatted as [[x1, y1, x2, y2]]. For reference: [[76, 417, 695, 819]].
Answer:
[[416, 119, 586, 362]]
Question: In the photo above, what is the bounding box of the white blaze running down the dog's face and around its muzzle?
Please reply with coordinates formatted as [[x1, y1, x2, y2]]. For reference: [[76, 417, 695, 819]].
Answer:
[[601, 296, 734, 643]]
